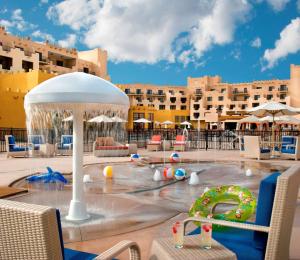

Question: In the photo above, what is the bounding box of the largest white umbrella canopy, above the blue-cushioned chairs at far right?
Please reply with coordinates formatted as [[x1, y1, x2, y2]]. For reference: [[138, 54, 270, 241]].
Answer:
[[247, 102, 300, 116]]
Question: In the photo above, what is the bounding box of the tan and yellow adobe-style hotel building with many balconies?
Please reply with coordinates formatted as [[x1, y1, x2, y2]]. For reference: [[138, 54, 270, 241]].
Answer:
[[0, 27, 300, 129]]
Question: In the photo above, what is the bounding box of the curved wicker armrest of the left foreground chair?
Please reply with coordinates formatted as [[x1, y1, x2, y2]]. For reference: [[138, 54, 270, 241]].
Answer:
[[95, 240, 141, 260]]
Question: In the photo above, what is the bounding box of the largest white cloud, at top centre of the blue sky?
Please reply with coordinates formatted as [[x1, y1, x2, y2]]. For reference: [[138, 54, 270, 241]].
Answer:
[[47, 0, 250, 64]]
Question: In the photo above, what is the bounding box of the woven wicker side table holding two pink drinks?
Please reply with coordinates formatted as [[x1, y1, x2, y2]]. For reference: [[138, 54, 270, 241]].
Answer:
[[149, 235, 237, 260]]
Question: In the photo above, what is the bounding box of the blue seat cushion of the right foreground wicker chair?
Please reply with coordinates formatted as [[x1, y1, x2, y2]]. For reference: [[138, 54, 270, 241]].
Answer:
[[189, 225, 265, 260]]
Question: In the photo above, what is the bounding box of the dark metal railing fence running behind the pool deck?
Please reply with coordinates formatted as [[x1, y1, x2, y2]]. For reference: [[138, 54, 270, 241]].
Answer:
[[0, 128, 300, 152]]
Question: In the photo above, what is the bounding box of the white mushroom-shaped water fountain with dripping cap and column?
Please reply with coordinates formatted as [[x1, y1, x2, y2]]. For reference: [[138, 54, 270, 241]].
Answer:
[[24, 72, 129, 221]]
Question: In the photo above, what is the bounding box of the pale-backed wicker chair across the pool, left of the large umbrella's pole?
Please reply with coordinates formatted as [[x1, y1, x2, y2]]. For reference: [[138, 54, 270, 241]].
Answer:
[[244, 136, 271, 160]]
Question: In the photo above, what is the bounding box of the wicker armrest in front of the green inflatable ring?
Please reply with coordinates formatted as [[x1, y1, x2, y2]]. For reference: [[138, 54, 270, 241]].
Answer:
[[183, 217, 270, 234]]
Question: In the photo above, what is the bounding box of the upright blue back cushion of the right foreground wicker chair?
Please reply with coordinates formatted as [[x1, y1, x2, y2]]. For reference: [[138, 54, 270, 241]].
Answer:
[[253, 172, 280, 249]]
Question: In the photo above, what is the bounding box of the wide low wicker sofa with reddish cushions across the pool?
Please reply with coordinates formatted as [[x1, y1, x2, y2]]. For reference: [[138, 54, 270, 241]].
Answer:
[[93, 137, 131, 157]]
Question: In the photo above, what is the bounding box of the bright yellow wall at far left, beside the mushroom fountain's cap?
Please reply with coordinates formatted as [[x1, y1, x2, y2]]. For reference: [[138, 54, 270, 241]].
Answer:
[[0, 70, 55, 128]]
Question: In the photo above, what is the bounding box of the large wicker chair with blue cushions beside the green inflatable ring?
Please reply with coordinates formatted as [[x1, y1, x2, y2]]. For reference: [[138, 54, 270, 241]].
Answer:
[[184, 165, 300, 260]]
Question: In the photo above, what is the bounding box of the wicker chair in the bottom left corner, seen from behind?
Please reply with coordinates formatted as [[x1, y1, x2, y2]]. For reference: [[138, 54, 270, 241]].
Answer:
[[0, 200, 140, 260]]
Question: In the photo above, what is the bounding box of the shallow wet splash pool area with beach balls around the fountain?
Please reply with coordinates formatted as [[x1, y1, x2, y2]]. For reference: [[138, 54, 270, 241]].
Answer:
[[14, 162, 285, 242]]
